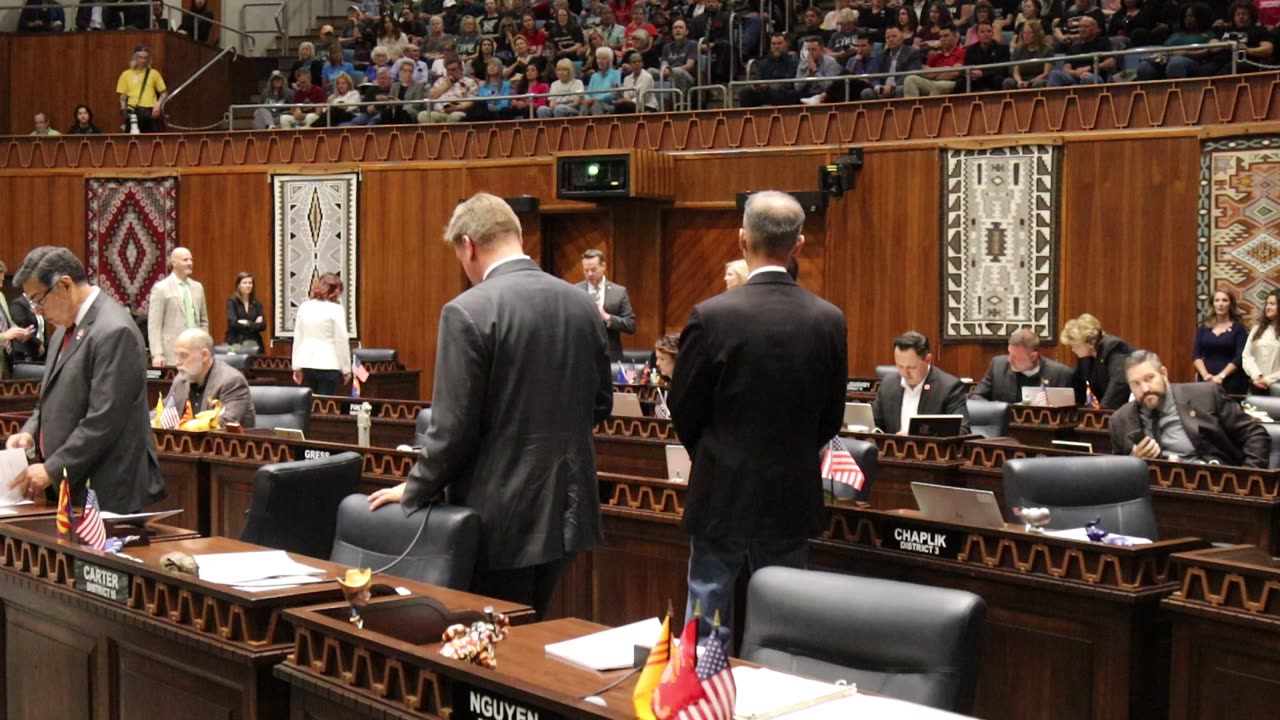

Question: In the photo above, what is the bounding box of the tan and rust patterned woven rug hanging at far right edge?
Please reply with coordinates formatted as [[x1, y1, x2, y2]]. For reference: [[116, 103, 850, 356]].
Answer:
[[1196, 136, 1280, 315]]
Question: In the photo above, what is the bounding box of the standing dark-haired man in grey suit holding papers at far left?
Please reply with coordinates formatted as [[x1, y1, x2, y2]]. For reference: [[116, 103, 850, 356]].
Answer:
[[5, 246, 165, 512]]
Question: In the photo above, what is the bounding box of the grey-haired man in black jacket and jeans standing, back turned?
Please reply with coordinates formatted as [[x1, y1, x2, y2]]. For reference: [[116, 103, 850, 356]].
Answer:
[[667, 192, 849, 632]]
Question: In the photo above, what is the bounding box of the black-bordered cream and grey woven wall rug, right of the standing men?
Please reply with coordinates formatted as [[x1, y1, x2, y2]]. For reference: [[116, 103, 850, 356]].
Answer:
[[942, 145, 1059, 342]]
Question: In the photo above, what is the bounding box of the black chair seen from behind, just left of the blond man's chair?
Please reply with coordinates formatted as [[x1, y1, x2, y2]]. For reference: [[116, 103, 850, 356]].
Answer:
[[241, 452, 365, 559]]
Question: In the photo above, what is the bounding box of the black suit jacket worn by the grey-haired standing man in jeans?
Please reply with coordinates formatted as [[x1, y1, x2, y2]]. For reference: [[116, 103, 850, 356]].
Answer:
[[667, 273, 849, 539]]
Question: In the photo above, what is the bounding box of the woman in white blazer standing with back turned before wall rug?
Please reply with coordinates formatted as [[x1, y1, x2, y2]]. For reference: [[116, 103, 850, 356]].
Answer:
[[293, 273, 351, 395]]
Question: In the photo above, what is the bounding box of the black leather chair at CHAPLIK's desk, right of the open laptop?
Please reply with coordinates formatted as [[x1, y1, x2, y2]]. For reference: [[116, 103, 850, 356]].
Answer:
[[1004, 455, 1158, 541]]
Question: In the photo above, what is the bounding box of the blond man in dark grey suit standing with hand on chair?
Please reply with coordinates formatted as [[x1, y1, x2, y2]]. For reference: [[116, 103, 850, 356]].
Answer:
[[370, 193, 613, 618]]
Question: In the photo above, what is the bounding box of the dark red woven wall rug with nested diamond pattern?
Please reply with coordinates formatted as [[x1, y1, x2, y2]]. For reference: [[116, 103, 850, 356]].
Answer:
[[84, 178, 178, 313]]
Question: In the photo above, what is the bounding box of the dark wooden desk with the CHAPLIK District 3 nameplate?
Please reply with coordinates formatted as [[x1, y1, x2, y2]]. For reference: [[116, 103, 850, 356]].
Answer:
[[809, 503, 1207, 720]]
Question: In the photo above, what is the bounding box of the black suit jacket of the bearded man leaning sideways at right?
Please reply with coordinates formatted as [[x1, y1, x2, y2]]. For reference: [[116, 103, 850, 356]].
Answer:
[[1111, 383, 1271, 468]]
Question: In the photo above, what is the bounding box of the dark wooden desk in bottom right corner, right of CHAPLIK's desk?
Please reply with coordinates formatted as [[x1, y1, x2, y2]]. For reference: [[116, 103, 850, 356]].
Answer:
[[1162, 546, 1280, 720]]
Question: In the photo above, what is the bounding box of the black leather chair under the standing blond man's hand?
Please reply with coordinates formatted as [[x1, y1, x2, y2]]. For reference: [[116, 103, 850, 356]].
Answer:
[[329, 495, 480, 591]]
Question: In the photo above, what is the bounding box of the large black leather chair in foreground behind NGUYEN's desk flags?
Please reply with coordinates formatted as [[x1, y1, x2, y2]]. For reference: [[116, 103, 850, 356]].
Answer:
[[741, 568, 987, 714]]
